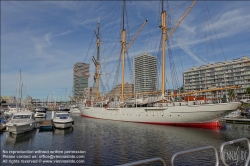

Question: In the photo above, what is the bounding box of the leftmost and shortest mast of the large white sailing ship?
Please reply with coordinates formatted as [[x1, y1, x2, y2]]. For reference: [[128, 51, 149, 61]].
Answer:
[[92, 18, 101, 100]]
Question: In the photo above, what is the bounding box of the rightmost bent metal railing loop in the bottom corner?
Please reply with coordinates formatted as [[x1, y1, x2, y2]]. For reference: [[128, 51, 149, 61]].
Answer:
[[220, 138, 250, 166]]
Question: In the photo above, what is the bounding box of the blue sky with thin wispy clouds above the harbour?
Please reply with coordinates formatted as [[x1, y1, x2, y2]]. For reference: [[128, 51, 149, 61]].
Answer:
[[1, 1, 250, 100]]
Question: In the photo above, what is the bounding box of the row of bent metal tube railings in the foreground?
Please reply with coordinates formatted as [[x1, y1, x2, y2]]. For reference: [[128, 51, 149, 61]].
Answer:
[[118, 138, 250, 166]]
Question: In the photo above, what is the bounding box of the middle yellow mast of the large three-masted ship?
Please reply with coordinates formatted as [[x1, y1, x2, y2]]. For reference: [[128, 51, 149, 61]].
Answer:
[[121, 0, 126, 101]]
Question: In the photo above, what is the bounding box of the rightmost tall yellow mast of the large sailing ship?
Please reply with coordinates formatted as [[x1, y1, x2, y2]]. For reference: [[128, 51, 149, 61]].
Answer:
[[160, 0, 167, 101]]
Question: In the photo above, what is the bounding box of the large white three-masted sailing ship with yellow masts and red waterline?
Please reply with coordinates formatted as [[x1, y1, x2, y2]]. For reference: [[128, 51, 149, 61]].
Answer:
[[78, 0, 240, 128]]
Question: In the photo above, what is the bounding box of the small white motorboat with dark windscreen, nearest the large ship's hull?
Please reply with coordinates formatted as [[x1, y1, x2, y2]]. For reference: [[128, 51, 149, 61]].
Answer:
[[52, 111, 74, 129]]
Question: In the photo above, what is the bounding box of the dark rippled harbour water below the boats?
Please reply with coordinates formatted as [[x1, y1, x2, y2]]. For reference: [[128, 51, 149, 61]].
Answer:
[[0, 112, 250, 166]]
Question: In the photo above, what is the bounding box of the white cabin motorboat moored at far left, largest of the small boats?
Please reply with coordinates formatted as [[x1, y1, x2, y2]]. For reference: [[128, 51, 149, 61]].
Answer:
[[6, 111, 35, 134]]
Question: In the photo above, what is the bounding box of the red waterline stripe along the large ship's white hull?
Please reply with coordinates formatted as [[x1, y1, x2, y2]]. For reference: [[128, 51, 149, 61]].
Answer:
[[81, 114, 222, 129]]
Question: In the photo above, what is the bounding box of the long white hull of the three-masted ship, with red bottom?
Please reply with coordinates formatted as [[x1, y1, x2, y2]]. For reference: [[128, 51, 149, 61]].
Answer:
[[78, 102, 240, 127]]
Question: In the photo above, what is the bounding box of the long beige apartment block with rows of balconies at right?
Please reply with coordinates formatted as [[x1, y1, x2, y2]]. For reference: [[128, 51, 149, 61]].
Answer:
[[183, 56, 250, 97]]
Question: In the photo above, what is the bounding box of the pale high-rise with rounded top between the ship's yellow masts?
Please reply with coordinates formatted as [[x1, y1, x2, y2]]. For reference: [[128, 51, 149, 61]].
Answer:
[[134, 54, 158, 93]]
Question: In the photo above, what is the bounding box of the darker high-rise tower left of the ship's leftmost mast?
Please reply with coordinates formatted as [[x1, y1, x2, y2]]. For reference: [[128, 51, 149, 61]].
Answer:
[[73, 62, 89, 99]]
